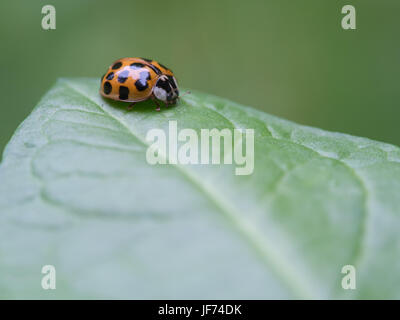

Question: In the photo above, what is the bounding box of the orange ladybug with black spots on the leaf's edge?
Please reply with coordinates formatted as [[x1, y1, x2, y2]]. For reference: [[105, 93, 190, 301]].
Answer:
[[100, 58, 179, 111]]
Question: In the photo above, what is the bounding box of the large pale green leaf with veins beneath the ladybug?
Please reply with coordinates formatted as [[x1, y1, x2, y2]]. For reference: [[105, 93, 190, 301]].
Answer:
[[0, 79, 400, 299]]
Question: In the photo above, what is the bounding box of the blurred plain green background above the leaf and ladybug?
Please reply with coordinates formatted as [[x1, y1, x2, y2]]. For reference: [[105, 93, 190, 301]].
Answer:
[[0, 0, 400, 155]]
